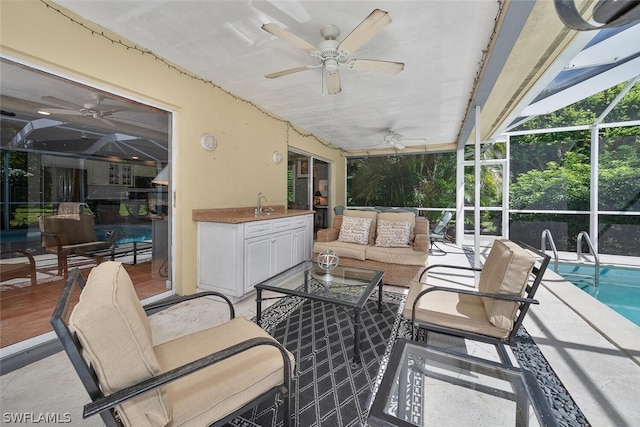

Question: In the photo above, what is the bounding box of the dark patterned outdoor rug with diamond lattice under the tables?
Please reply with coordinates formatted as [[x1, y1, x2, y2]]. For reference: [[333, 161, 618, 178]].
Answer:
[[229, 291, 589, 427]]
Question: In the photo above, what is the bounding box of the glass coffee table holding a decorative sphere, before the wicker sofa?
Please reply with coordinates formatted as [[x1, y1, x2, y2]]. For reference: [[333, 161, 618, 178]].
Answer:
[[255, 261, 384, 363]]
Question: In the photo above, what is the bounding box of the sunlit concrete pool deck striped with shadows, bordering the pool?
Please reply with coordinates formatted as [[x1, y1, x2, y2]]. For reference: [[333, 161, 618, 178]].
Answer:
[[525, 253, 640, 426]]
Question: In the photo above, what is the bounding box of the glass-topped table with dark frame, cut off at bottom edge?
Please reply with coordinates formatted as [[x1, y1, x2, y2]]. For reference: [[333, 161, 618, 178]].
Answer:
[[368, 339, 557, 427]]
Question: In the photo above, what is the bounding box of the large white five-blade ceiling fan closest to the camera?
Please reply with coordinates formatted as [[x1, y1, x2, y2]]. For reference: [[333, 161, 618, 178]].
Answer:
[[262, 9, 404, 95]]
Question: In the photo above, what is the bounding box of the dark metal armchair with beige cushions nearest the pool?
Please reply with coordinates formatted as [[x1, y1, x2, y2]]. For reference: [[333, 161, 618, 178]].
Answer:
[[403, 239, 550, 364]]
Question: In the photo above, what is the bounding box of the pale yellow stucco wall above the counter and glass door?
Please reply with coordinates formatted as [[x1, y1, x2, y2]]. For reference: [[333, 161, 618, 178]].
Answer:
[[0, 0, 345, 294]]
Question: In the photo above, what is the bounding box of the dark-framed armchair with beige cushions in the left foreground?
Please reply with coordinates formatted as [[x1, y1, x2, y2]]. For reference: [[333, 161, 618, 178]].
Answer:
[[51, 261, 294, 427]]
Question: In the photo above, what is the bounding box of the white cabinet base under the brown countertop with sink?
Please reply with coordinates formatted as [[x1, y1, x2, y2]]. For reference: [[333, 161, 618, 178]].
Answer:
[[198, 215, 313, 298]]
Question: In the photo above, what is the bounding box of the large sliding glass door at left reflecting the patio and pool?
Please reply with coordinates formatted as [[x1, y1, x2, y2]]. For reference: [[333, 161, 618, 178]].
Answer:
[[0, 58, 171, 347]]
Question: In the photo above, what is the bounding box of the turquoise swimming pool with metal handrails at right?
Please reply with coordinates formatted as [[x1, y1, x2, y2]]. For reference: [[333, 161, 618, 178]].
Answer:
[[558, 263, 640, 326]]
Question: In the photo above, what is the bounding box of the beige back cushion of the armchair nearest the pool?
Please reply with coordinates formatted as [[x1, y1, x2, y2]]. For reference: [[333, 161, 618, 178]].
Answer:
[[478, 239, 535, 331]]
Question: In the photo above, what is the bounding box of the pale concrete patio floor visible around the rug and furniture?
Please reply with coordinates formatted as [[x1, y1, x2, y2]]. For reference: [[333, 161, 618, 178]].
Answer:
[[0, 244, 640, 427]]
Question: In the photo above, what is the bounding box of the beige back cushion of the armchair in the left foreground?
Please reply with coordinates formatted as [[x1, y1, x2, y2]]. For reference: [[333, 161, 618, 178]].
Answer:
[[69, 261, 171, 427]]
